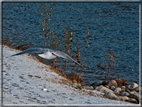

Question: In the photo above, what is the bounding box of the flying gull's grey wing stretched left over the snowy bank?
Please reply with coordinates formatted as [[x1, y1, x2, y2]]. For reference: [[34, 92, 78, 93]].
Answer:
[[12, 48, 48, 56]]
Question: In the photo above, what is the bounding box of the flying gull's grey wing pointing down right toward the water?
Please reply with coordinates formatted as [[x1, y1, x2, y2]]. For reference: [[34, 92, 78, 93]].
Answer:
[[49, 49, 82, 66]]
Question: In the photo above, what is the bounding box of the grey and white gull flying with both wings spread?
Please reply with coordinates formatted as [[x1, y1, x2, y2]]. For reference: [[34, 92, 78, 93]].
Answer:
[[12, 48, 82, 66]]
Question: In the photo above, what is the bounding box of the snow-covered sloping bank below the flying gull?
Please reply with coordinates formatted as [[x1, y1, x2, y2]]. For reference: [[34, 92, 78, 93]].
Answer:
[[3, 46, 135, 105]]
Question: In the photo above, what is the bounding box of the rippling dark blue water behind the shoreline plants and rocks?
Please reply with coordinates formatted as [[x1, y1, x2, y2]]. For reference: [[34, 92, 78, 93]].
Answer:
[[2, 3, 139, 84]]
